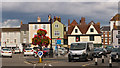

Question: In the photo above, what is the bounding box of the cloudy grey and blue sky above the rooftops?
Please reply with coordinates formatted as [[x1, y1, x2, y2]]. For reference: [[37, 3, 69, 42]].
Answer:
[[0, 0, 118, 27]]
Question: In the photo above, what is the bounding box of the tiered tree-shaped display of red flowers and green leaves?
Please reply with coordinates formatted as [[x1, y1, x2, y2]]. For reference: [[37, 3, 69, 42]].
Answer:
[[32, 29, 51, 50]]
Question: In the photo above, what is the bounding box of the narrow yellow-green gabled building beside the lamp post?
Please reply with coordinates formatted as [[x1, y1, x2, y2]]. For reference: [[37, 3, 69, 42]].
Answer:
[[52, 16, 66, 45]]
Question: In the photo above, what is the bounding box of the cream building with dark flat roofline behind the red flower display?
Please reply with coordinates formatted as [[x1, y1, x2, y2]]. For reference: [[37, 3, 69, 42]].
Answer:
[[29, 17, 51, 47]]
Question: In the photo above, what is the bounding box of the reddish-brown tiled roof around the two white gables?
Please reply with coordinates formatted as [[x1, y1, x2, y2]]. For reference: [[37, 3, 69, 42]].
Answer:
[[68, 20, 101, 35]]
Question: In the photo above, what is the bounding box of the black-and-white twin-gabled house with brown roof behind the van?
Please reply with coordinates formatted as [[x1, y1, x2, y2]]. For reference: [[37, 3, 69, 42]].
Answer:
[[68, 17, 101, 46]]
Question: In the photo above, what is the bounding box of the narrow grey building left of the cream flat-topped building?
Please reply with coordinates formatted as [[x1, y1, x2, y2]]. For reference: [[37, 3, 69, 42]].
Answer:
[[20, 21, 29, 48]]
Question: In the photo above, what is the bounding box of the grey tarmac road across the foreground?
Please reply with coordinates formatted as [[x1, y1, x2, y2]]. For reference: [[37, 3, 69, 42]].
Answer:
[[2, 54, 120, 68]]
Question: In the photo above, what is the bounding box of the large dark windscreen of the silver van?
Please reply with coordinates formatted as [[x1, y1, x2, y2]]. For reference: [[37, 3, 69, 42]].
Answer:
[[70, 43, 86, 50]]
